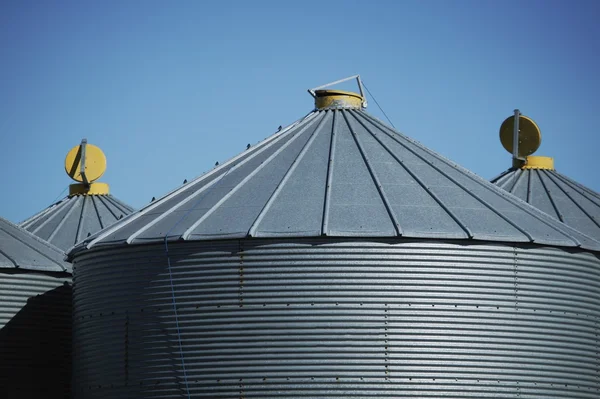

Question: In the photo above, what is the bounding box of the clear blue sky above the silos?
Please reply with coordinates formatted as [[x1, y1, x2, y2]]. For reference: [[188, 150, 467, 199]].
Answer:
[[0, 0, 600, 222]]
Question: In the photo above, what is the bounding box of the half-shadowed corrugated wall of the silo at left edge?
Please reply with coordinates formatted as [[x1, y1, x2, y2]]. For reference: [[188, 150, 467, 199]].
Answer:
[[0, 269, 72, 399]]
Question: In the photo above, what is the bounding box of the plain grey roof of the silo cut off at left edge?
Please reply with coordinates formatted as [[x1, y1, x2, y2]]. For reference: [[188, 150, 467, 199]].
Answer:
[[0, 218, 71, 273]]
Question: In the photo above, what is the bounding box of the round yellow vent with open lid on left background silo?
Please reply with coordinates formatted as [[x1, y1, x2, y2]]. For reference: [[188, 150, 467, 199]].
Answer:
[[65, 139, 109, 196]]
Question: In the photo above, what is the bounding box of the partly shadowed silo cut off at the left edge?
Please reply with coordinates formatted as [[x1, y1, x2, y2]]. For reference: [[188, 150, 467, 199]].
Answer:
[[0, 218, 72, 399]]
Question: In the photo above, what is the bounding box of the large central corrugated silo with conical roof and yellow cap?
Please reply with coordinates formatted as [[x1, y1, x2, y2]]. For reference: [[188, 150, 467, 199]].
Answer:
[[70, 83, 600, 398]]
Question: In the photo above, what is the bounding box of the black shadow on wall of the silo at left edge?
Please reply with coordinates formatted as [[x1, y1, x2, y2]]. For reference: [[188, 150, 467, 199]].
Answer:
[[0, 283, 72, 399]]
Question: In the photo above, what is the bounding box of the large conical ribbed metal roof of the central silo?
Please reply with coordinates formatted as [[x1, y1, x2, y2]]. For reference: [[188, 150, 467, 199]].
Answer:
[[72, 108, 600, 254]]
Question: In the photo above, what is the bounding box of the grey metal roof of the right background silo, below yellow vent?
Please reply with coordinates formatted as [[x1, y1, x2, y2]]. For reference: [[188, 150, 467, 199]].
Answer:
[[492, 169, 600, 240]]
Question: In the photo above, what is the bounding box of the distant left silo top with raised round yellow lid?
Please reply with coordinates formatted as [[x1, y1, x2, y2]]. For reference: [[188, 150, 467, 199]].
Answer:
[[19, 139, 133, 251]]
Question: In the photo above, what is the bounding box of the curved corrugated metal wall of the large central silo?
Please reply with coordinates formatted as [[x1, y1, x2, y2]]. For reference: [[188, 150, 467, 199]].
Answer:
[[74, 240, 600, 399]]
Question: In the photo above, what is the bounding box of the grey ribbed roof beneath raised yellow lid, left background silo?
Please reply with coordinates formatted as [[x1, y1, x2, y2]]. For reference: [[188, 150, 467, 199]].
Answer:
[[19, 195, 133, 251]]
